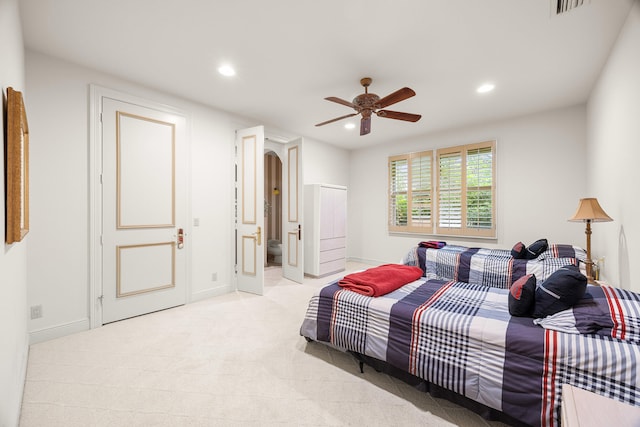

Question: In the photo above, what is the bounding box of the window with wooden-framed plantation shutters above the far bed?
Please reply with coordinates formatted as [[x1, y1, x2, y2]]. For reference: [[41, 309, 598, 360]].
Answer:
[[389, 141, 496, 237]]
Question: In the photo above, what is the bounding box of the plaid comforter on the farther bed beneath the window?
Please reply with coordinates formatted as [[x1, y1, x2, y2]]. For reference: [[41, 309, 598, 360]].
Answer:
[[403, 244, 586, 289]]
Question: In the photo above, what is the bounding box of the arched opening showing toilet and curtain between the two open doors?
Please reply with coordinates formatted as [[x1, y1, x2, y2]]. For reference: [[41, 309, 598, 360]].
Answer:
[[264, 149, 282, 267]]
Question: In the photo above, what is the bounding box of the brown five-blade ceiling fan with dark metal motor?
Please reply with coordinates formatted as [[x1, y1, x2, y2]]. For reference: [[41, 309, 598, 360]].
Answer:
[[316, 77, 422, 135]]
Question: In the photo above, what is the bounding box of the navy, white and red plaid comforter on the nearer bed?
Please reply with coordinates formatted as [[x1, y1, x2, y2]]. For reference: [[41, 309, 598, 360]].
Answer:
[[300, 279, 640, 426]]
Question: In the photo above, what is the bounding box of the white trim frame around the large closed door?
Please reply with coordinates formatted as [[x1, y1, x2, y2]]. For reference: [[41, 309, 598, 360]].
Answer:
[[87, 84, 191, 329]]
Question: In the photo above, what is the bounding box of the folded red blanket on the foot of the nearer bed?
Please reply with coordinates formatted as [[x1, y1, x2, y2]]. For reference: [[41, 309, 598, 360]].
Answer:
[[338, 264, 422, 297]]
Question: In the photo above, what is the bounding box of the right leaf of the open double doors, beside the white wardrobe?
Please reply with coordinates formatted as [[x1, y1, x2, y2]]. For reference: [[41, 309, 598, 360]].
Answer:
[[282, 138, 304, 283]]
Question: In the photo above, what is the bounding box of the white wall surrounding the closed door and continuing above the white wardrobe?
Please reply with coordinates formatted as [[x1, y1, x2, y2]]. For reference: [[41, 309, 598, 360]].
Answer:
[[26, 51, 348, 342]]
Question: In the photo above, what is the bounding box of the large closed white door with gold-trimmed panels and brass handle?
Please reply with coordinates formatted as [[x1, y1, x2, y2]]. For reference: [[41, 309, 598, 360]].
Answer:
[[101, 97, 189, 323]]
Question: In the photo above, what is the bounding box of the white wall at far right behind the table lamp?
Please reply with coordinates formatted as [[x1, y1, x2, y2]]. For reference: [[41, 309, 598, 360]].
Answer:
[[587, 0, 640, 292]]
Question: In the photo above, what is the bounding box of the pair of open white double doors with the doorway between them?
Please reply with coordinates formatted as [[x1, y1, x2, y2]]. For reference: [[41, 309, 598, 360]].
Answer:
[[233, 130, 304, 295]]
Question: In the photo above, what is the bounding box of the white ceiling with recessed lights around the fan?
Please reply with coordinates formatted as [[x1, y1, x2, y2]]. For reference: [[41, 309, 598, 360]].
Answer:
[[19, 0, 633, 149]]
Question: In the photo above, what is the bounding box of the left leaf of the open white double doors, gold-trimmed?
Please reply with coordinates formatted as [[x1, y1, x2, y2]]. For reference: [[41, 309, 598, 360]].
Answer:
[[236, 126, 266, 295]]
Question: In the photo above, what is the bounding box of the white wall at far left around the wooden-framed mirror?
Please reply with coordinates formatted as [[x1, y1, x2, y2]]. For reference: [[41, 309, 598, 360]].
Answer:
[[0, 0, 32, 426]]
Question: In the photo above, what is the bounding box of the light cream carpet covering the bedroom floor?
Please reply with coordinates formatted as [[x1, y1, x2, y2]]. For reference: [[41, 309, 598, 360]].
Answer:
[[20, 263, 510, 427]]
